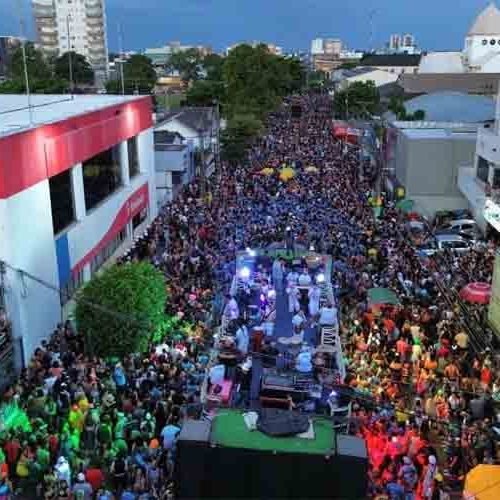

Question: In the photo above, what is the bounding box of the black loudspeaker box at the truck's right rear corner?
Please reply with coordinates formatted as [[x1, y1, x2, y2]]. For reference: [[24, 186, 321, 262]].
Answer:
[[334, 434, 368, 500]]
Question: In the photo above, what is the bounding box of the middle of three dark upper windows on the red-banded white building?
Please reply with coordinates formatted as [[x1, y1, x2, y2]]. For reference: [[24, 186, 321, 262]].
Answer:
[[82, 145, 121, 210]]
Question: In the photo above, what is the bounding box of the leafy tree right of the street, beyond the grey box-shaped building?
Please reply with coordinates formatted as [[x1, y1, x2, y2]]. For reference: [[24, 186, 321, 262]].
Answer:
[[333, 80, 380, 118]]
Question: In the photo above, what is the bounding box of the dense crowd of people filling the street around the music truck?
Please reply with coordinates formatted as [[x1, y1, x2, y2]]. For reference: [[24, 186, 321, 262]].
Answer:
[[0, 96, 500, 500]]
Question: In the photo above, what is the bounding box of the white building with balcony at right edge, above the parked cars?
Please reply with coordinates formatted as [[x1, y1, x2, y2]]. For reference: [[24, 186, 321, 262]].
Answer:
[[458, 85, 500, 236]]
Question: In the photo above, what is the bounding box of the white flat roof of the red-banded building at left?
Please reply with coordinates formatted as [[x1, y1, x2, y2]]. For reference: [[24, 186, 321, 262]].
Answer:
[[0, 94, 144, 137]]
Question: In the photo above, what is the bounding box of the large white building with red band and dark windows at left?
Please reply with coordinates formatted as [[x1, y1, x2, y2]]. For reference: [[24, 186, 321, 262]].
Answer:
[[0, 95, 156, 360]]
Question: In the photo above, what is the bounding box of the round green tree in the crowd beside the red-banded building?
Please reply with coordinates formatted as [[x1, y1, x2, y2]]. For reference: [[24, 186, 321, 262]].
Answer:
[[75, 262, 166, 356]]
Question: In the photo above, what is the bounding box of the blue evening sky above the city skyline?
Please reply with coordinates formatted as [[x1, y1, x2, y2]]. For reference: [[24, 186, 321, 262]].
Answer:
[[0, 0, 496, 50]]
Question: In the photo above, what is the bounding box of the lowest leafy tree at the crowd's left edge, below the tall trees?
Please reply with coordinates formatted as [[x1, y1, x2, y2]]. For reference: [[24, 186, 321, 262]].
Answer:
[[221, 113, 263, 164]]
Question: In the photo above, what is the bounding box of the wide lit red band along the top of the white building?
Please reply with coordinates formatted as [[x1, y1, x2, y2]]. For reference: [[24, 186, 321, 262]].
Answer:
[[0, 97, 153, 199]]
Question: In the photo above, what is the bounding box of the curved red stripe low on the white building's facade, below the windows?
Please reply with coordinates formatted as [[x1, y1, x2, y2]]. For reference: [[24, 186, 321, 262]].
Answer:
[[70, 183, 149, 273]]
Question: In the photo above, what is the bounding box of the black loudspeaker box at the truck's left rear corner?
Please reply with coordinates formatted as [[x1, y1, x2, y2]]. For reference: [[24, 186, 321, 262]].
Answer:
[[174, 420, 211, 499]]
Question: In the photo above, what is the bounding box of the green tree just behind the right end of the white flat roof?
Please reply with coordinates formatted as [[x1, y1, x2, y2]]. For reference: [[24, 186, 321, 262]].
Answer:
[[106, 54, 157, 94]]
